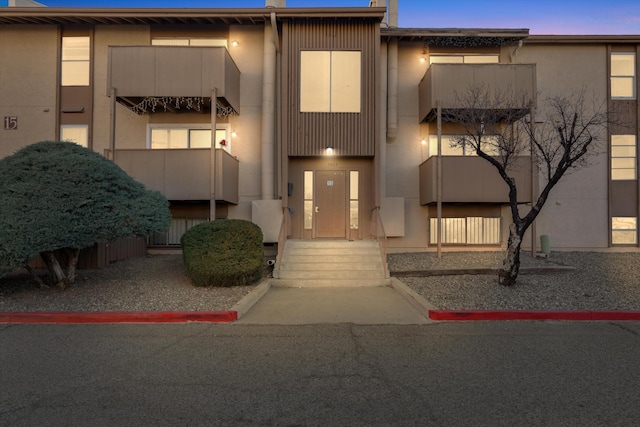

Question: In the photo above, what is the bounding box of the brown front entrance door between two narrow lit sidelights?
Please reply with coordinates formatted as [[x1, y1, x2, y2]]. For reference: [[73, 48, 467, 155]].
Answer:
[[314, 171, 347, 238]]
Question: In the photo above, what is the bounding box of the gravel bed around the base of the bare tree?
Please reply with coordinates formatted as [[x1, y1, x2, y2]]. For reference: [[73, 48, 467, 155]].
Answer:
[[389, 252, 640, 310]]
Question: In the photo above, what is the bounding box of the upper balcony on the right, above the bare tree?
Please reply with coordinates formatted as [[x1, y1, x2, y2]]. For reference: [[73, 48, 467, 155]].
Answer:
[[419, 64, 536, 122]]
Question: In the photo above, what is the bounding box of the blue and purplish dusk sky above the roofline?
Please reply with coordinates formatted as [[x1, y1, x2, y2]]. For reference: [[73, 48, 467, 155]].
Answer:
[[31, 0, 640, 35]]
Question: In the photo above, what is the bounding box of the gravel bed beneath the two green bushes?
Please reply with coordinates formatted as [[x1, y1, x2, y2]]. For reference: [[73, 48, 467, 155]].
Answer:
[[0, 255, 257, 312]]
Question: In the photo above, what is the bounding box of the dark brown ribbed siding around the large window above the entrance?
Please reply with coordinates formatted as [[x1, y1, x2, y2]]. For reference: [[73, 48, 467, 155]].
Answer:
[[282, 20, 380, 156]]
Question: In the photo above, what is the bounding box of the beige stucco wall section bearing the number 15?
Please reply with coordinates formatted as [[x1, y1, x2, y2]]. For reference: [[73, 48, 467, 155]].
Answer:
[[0, 26, 58, 157]]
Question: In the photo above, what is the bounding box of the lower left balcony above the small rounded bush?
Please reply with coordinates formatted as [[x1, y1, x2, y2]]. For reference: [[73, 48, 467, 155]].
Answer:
[[107, 148, 239, 204]]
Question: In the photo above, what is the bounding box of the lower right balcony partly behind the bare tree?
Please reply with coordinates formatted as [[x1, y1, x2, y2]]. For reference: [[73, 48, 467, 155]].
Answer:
[[420, 156, 531, 205]]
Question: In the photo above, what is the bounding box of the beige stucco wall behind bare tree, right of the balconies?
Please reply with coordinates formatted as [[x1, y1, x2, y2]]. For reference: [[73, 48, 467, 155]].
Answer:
[[517, 45, 609, 248]]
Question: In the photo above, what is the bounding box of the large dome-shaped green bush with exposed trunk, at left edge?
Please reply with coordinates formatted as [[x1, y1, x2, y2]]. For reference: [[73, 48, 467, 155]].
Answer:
[[0, 141, 171, 289]]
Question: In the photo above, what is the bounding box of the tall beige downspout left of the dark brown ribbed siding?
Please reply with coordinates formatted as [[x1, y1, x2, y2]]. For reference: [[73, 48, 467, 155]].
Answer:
[[262, 12, 277, 200]]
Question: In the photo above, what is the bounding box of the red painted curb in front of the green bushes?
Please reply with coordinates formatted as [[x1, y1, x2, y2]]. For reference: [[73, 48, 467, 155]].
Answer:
[[0, 311, 238, 323]]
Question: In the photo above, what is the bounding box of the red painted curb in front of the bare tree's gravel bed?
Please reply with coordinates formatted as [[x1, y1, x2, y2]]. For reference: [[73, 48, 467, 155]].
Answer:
[[429, 310, 640, 321]]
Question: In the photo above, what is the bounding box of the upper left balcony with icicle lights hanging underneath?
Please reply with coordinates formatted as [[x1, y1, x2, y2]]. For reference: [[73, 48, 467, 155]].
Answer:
[[107, 46, 240, 114]]
